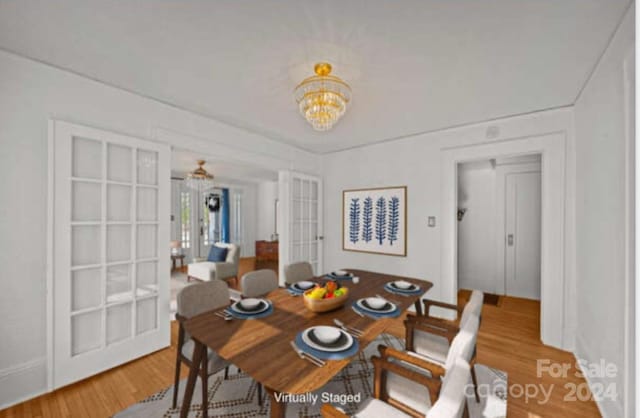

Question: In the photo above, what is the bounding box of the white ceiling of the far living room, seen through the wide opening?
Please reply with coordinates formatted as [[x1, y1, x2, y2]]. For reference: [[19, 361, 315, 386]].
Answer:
[[171, 149, 278, 183]]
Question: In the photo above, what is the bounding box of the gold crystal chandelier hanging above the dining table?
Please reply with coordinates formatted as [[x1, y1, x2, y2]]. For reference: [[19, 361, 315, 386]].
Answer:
[[294, 62, 351, 131]]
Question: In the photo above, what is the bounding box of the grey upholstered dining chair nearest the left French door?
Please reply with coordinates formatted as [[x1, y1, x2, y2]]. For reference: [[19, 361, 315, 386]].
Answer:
[[173, 280, 230, 408]]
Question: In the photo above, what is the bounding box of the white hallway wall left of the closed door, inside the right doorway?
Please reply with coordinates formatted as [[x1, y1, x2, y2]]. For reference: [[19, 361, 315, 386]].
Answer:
[[458, 161, 499, 293]]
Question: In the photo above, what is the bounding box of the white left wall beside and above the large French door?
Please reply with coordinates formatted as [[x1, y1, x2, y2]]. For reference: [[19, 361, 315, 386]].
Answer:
[[0, 52, 320, 409]]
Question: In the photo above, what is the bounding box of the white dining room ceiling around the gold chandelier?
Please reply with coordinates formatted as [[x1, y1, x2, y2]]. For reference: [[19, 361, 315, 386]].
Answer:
[[0, 0, 630, 153]]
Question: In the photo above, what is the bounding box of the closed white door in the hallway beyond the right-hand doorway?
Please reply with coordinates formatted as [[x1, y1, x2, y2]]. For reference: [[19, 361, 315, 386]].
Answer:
[[505, 172, 541, 300]]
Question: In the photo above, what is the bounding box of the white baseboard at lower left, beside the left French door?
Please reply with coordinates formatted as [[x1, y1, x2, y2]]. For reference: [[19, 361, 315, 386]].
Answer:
[[0, 357, 47, 410]]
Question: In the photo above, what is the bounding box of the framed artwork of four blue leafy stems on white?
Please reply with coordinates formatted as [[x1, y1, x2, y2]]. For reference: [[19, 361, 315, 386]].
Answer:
[[342, 186, 407, 257]]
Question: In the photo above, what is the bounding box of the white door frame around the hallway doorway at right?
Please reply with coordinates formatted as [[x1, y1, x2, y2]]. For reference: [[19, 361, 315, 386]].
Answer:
[[440, 131, 572, 348]]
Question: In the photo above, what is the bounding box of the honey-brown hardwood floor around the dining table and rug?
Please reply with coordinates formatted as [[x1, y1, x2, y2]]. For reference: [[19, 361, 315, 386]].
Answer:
[[0, 270, 600, 418]]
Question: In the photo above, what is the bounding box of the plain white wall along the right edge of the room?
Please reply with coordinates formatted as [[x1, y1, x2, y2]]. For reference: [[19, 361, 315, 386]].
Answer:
[[575, 7, 635, 417]]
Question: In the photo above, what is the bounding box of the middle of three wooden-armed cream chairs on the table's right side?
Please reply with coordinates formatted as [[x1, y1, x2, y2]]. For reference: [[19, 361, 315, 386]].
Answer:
[[405, 313, 480, 402]]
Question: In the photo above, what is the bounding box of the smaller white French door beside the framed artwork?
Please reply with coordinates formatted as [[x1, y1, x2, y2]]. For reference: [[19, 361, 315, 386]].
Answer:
[[278, 171, 323, 282]]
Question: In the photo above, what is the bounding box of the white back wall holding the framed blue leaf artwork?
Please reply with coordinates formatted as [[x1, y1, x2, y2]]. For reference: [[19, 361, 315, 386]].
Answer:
[[323, 108, 575, 342]]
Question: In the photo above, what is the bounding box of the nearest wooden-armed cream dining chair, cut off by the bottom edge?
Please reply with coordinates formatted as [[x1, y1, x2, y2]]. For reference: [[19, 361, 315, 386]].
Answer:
[[321, 345, 469, 418]]
